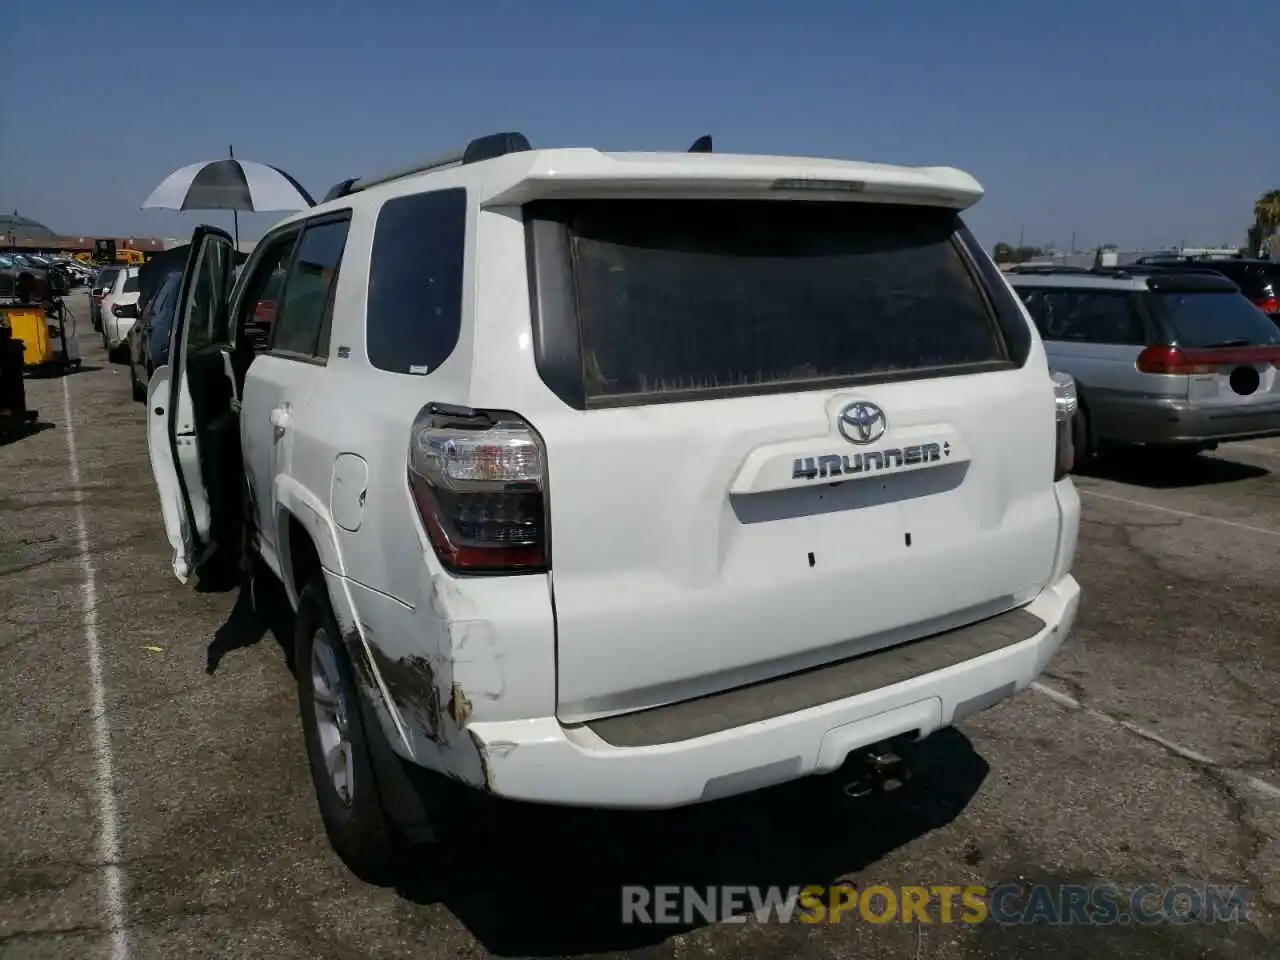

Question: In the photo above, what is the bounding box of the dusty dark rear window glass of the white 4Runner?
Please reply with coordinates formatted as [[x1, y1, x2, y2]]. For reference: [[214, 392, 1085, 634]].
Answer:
[[568, 200, 1006, 398]]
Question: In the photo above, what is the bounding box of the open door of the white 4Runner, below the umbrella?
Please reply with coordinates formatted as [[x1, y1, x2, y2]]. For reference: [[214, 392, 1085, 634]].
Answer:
[[147, 227, 243, 582]]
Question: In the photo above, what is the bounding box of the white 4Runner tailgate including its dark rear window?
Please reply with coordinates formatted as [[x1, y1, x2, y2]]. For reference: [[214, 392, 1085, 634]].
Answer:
[[519, 200, 1060, 721]]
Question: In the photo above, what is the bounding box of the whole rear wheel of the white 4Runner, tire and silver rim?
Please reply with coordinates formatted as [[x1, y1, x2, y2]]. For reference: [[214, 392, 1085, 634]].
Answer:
[[294, 579, 402, 883]]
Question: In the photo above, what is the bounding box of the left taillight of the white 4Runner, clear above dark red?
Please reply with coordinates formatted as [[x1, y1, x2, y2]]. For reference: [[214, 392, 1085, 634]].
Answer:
[[408, 403, 548, 573]]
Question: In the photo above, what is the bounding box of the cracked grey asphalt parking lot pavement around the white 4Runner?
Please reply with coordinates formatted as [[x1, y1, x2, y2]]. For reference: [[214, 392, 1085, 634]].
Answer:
[[0, 298, 1280, 960]]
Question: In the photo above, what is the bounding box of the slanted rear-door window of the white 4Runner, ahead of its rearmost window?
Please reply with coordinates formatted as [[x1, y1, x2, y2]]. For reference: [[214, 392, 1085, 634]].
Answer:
[[271, 219, 351, 357]]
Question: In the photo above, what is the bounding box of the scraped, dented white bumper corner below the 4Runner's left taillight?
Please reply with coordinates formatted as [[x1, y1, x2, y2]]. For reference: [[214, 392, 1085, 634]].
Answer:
[[330, 564, 556, 792]]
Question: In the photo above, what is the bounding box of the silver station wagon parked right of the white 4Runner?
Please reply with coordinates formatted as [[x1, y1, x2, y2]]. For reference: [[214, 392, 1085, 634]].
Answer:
[[1007, 265, 1280, 468]]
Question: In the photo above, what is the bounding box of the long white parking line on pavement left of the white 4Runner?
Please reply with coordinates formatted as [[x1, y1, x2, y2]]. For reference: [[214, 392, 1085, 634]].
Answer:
[[63, 379, 129, 960]]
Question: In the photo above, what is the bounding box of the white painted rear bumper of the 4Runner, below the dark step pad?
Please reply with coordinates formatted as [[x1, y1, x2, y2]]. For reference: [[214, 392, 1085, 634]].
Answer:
[[468, 575, 1080, 809]]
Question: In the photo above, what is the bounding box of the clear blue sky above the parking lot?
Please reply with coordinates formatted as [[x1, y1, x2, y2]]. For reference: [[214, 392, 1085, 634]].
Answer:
[[0, 0, 1280, 247]]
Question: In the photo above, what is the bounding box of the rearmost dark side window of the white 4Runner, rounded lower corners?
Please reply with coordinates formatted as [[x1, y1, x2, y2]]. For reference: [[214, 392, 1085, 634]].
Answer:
[[365, 187, 467, 374]]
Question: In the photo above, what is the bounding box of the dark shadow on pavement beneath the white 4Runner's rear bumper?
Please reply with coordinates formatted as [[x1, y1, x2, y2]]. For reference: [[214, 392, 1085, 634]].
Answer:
[[398, 728, 989, 956]]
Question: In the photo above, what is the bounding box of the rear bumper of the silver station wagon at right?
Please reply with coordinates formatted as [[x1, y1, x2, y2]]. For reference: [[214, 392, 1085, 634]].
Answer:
[[1098, 399, 1280, 444]]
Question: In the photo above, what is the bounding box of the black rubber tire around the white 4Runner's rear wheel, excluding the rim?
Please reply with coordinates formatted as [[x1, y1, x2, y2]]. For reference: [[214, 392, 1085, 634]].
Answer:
[[293, 579, 403, 883]]
